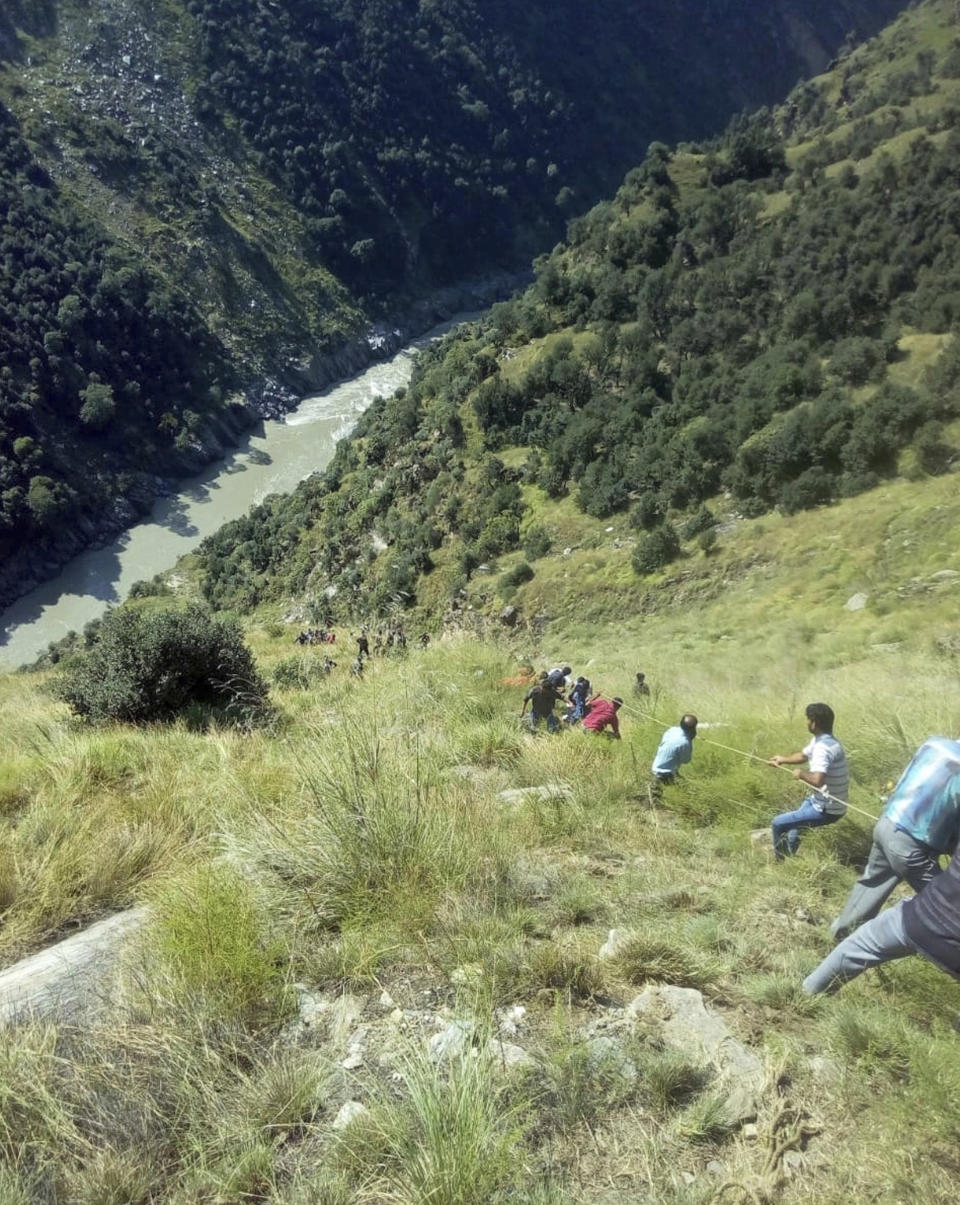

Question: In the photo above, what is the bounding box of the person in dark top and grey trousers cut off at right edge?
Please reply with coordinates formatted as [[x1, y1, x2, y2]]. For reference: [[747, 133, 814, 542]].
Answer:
[[803, 838, 960, 995]]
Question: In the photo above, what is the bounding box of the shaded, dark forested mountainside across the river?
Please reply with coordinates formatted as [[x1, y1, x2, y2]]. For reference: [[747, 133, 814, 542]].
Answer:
[[0, 0, 901, 598]]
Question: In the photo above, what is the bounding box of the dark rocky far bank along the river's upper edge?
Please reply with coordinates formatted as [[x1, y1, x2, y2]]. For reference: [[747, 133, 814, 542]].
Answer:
[[0, 272, 526, 612]]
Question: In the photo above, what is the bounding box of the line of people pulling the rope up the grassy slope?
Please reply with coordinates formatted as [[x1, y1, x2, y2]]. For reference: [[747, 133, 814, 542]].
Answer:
[[520, 666, 960, 995]]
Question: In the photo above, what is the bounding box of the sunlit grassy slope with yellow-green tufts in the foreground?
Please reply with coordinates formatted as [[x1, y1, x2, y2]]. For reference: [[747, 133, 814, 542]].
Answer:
[[0, 465, 960, 1205]]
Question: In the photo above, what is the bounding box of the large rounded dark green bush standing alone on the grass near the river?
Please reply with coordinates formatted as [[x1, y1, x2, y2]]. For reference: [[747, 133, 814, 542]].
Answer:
[[57, 605, 267, 723]]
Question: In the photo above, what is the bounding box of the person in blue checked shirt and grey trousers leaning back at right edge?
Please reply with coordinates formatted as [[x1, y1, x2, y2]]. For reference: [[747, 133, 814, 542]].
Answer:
[[830, 736, 960, 941]]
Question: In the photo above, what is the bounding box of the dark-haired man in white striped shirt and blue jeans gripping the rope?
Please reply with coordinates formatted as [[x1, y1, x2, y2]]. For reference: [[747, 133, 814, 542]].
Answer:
[[767, 703, 849, 862]]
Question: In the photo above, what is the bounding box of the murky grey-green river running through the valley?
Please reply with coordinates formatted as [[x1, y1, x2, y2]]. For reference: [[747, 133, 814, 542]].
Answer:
[[0, 315, 467, 669]]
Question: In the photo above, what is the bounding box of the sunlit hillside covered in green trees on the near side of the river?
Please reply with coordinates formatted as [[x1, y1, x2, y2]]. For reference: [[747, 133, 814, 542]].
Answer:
[[195, 4, 960, 613]]
